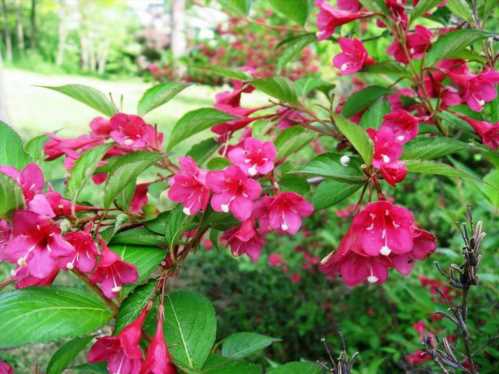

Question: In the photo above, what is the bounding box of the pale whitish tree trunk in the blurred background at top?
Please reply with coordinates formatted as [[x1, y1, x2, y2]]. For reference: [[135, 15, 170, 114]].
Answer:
[[170, 0, 187, 77]]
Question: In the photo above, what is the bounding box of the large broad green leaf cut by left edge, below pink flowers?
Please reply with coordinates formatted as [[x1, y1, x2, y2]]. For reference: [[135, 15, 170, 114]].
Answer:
[[0, 287, 112, 348]]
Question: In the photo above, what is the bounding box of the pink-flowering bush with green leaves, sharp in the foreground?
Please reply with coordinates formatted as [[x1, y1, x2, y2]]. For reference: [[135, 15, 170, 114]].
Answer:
[[0, 0, 499, 373]]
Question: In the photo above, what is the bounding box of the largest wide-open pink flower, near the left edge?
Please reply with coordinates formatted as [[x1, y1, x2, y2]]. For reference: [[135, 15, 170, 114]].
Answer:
[[3, 210, 74, 279]]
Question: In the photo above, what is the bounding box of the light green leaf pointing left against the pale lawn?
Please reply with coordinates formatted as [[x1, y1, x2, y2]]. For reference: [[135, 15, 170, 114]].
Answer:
[[41, 84, 118, 117]]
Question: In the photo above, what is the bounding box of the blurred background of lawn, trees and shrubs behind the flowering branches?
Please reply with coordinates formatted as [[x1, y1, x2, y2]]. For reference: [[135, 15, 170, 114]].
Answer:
[[0, 0, 499, 373]]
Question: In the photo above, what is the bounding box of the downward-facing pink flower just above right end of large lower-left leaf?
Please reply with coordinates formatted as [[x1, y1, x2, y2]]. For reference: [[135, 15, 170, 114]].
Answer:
[[90, 242, 138, 299]]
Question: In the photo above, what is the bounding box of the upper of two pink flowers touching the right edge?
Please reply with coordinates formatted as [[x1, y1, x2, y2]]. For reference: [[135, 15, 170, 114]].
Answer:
[[449, 70, 499, 112]]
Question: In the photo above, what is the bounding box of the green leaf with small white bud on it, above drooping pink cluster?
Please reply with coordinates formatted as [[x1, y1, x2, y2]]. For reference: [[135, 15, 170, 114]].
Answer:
[[296, 153, 365, 184]]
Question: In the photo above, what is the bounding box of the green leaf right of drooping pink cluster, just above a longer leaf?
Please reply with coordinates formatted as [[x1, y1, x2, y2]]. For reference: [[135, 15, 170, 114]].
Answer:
[[402, 137, 468, 160]]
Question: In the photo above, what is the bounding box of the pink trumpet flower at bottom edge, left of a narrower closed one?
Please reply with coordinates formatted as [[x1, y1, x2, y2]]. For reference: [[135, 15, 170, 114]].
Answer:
[[87, 309, 147, 374]]
